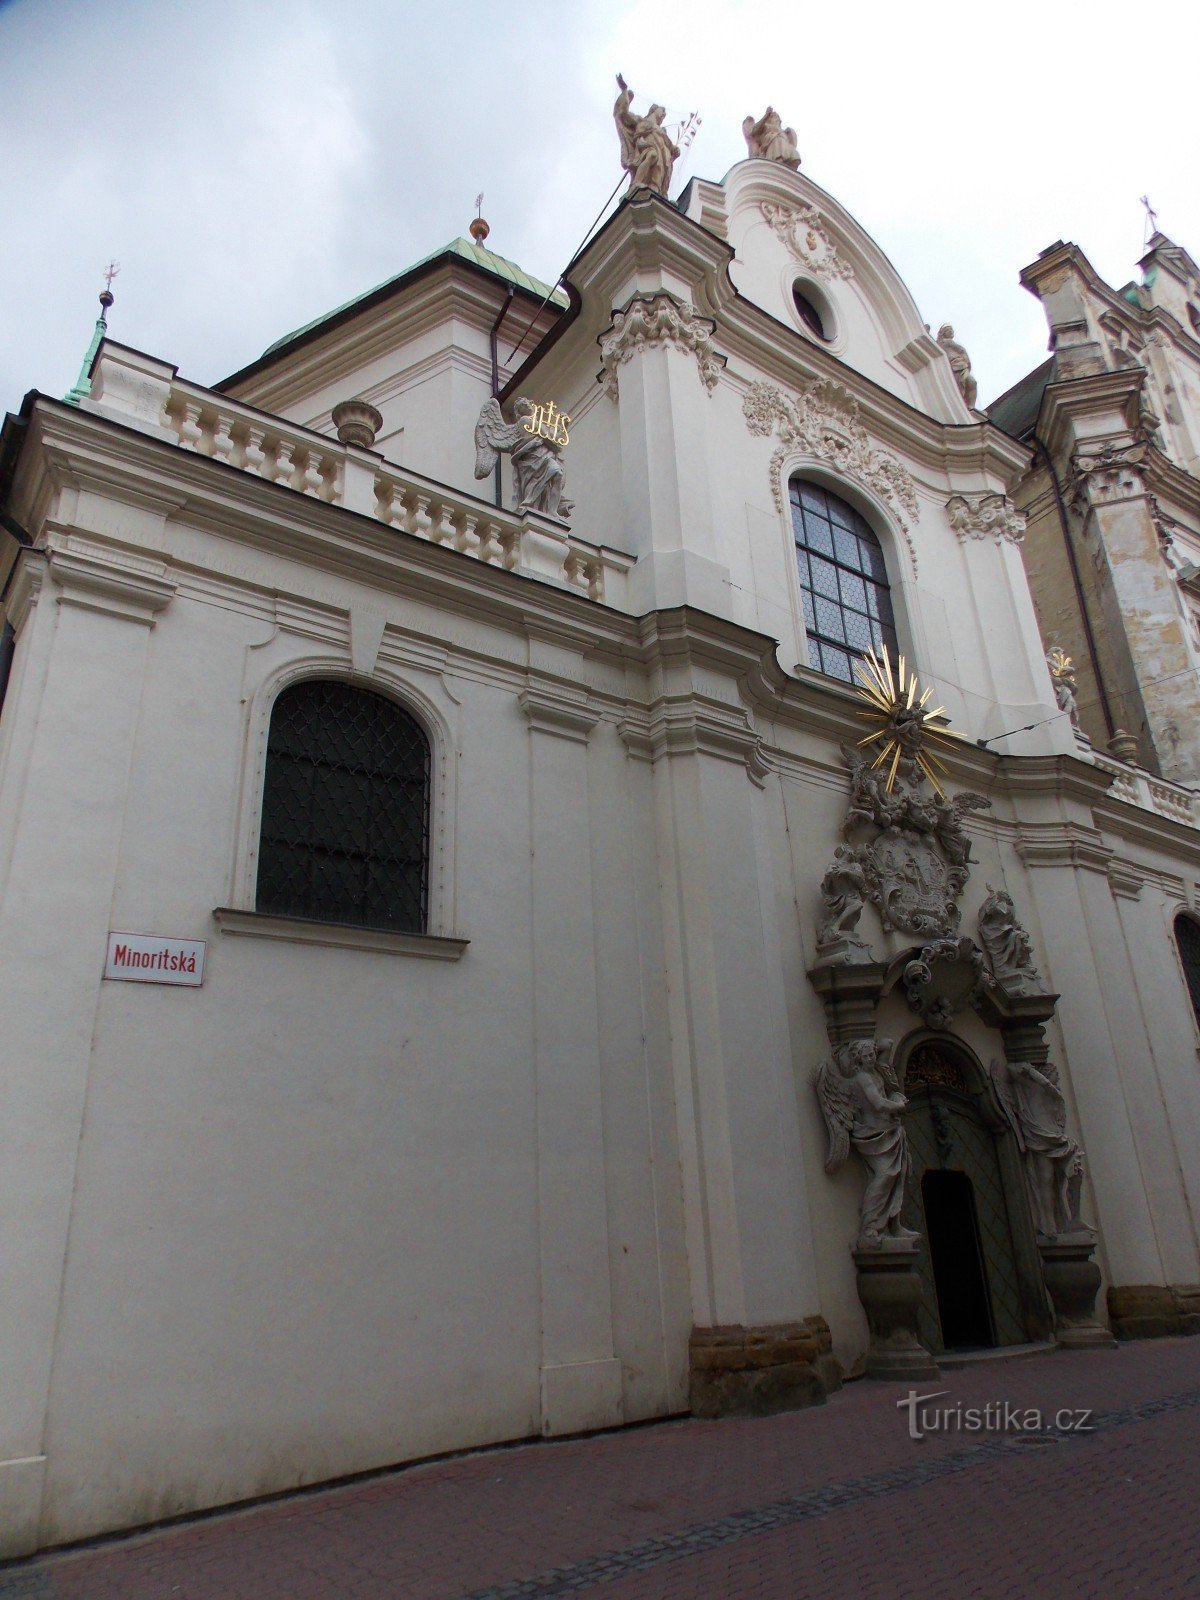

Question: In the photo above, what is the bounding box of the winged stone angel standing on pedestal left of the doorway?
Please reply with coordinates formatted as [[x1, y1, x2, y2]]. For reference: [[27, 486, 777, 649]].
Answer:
[[813, 1038, 918, 1250]]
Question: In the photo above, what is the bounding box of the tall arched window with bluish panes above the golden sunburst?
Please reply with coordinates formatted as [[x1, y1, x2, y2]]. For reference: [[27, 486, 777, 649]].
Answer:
[[790, 478, 896, 683]]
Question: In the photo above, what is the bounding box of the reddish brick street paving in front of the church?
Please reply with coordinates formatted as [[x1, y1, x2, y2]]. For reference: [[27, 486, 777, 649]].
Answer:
[[0, 1339, 1200, 1600]]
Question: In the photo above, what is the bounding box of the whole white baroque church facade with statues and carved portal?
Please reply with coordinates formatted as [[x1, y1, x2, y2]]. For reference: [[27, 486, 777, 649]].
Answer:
[[0, 116, 1200, 1555]]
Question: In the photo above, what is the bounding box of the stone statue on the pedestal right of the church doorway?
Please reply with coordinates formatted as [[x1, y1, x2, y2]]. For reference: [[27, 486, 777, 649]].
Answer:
[[992, 1061, 1088, 1238]]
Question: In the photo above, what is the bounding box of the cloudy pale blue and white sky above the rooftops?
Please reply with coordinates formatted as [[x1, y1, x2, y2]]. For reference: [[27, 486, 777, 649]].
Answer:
[[0, 0, 1200, 410]]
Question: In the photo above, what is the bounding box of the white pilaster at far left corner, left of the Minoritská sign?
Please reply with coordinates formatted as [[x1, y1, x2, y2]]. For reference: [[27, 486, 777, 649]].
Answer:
[[0, 533, 174, 1555]]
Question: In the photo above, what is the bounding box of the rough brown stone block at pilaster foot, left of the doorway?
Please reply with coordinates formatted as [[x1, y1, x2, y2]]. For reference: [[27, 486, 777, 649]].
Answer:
[[690, 1317, 842, 1418]]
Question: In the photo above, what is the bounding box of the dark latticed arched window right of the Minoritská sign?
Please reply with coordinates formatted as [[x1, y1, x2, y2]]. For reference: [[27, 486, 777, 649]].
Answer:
[[258, 678, 430, 933]]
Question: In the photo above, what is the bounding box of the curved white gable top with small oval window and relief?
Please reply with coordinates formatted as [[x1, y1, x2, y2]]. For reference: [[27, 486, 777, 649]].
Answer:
[[686, 160, 976, 424]]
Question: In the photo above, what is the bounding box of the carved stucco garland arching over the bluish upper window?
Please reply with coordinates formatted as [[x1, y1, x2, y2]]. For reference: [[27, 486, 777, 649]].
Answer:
[[742, 378, 917, 556]]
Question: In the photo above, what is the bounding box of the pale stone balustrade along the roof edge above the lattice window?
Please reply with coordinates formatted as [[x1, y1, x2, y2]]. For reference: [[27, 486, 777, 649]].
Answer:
[[83, 341, 634, 608]]
